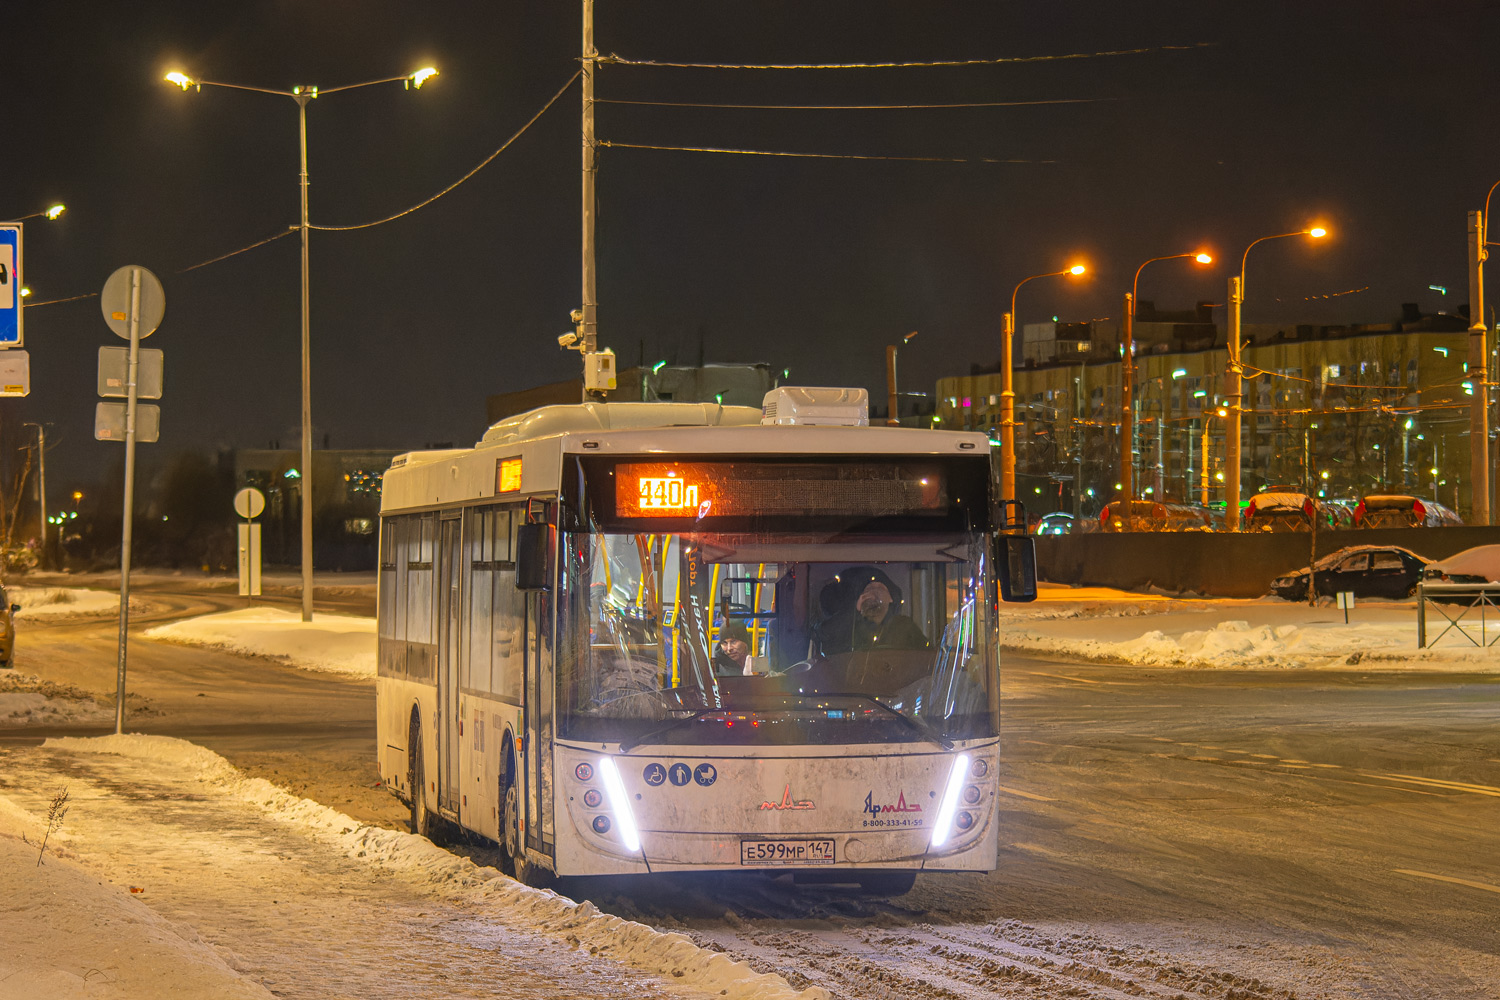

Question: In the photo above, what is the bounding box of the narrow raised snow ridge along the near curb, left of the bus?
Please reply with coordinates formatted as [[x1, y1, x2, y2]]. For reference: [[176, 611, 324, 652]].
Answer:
[[45, 735, 828, 1000]]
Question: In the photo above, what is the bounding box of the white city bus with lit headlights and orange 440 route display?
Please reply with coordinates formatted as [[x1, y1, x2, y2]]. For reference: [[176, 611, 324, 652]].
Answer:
[[377, 388, 1035, 892]]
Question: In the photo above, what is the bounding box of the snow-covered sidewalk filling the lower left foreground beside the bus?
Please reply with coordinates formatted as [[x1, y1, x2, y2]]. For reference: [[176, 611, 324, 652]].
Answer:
[[0, 736, 827, 1000]]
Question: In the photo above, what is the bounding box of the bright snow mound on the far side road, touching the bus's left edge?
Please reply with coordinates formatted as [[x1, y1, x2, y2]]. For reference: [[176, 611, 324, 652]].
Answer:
[[141, 607, 375, 678]]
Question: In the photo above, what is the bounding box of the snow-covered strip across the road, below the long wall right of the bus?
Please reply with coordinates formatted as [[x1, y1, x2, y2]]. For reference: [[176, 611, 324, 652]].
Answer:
[[1001, 586, 1500, 673]]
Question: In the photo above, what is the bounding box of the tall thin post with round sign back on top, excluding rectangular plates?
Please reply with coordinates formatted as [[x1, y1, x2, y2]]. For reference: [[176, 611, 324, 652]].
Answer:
[[95, 264, 167, 735]]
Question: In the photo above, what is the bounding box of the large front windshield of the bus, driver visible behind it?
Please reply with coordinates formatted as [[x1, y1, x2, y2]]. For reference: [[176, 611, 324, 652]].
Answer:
[[557, 528, 999, 745]]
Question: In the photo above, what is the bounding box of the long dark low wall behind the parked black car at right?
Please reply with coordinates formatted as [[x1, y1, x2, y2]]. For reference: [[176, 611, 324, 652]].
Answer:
[[1037, 528, 1500, 597]]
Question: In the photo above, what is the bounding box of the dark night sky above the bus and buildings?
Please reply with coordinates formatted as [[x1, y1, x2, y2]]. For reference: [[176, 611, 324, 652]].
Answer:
[[0, 0, 1500, 480]]
